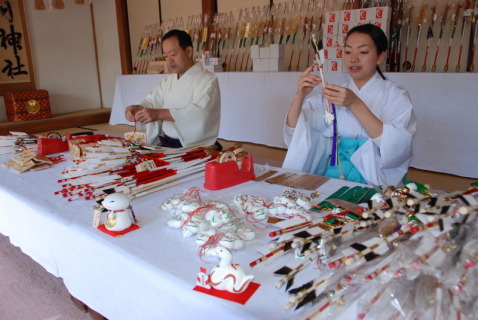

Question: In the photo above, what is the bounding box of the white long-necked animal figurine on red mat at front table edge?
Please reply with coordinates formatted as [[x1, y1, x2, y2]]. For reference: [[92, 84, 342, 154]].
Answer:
[[208, 246, 254, 293]]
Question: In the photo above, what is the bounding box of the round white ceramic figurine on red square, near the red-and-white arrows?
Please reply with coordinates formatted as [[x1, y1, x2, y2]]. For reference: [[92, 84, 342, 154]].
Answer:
[[102, 193, 135, 231]]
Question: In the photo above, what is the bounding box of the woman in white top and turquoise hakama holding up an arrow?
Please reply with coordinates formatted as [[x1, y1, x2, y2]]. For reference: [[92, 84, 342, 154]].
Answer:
[[283, 24, 416, 186]]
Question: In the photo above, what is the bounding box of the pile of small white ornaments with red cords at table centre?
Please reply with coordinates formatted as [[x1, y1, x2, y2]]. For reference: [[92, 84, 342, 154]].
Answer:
[[161, 191, 256, 250]]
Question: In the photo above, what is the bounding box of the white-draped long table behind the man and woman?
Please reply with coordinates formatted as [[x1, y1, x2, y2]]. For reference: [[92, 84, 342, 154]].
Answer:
[[110, 72, 478, 178]]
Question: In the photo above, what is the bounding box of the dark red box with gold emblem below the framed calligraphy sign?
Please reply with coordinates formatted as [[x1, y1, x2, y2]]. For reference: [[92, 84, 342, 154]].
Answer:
[[3, 90, 51, 122]]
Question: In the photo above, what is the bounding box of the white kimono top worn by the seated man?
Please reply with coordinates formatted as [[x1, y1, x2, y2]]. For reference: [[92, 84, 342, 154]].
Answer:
[[137, 62, 221, 147]]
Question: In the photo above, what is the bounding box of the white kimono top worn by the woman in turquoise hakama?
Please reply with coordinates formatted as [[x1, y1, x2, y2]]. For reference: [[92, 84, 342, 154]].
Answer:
[[283, 73, 416, 186]]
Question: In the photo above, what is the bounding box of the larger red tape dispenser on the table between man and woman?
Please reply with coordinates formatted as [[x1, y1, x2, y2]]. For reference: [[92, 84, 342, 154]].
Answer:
[[204, 156, 256, 190]]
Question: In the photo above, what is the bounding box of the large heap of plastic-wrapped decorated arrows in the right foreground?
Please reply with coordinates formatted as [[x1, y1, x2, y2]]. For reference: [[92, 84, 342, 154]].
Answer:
[[250, 183, 478, 319]]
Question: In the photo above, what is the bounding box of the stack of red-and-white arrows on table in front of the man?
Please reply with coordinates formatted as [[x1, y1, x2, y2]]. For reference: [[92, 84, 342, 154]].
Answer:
[[55, 142, 217, 201]]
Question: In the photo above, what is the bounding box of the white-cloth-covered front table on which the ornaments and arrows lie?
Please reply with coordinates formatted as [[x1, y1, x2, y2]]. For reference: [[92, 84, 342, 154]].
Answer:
[[0, 156, 362, 320]]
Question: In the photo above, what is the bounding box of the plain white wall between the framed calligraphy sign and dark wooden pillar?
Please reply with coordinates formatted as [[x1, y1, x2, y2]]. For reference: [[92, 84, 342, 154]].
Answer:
[[0, 0, 121, 121]]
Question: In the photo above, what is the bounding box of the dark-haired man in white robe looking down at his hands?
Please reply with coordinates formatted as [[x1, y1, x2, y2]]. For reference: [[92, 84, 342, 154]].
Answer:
[[125, 30, 221, 147]]
